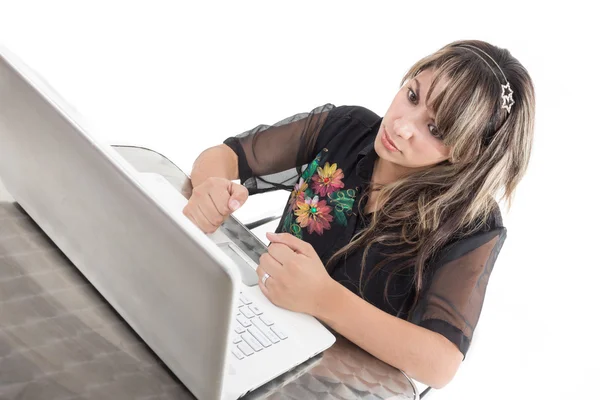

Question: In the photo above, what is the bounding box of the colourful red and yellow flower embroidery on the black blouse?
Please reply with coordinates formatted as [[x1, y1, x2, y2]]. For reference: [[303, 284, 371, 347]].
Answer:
[[282, 149, 356, 239]]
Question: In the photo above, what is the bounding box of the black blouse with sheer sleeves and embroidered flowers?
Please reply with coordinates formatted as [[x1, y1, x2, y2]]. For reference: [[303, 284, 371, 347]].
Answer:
[[224, 104, 506, 355]]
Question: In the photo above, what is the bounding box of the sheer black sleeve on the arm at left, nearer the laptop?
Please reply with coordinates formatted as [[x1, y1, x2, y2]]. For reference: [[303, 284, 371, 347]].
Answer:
[[223, 103, 335, 194]]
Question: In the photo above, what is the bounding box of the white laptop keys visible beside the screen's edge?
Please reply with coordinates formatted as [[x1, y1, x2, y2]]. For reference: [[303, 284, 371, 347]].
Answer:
[[232, 293, 287, 360]]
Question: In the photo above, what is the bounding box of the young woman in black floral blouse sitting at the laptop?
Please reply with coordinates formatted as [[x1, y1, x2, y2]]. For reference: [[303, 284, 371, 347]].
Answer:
[[184, 40, 535, 388]]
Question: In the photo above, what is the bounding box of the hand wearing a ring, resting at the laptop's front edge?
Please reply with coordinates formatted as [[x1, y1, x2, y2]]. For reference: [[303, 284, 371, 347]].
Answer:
[[256, 233, 337, 316]]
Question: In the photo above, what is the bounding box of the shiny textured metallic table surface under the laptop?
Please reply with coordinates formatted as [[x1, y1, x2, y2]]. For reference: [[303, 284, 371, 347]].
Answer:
[[0, 146, 418, 400]]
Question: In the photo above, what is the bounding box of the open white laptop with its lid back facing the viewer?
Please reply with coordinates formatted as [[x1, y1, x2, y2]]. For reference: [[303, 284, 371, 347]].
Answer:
[[0, 46, 335, 400]]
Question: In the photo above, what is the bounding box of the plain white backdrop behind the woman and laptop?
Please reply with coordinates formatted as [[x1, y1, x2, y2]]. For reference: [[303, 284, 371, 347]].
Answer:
[[0, 0, 600, 399]]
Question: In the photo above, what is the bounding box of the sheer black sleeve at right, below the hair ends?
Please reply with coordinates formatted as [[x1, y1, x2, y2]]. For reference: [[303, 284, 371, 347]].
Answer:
[[411, 223, 506, 357]]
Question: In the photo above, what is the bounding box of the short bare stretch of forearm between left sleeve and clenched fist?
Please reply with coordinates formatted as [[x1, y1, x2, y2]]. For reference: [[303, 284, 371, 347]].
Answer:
[[191, 144, 239, 187]]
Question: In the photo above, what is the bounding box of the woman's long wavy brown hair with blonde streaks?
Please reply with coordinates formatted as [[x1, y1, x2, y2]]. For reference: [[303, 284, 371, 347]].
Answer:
[[326, 40, 535, 309]]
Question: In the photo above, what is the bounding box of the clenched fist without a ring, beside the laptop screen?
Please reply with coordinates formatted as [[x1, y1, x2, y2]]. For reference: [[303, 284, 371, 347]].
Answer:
[[183, 177, 248, 233]]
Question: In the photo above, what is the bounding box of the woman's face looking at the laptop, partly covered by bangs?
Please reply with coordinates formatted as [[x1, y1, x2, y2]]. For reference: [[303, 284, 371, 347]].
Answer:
[[375, 70, 450, 169]]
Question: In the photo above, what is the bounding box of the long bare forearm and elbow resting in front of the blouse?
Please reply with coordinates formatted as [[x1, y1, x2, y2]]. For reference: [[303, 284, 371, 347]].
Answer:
[[315, 282, 463, 388]]
